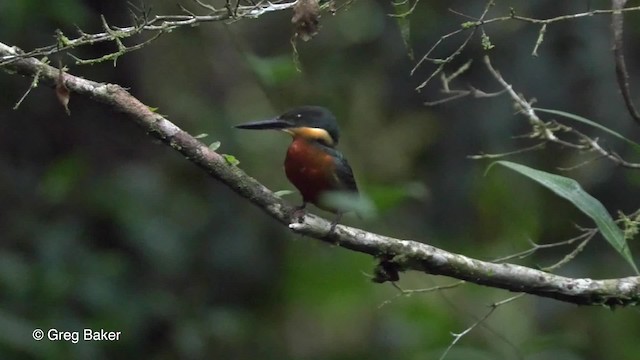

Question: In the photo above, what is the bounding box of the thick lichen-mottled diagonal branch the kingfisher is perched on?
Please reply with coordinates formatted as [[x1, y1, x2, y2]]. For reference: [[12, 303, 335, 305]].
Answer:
[[0, 43, 640, 306]]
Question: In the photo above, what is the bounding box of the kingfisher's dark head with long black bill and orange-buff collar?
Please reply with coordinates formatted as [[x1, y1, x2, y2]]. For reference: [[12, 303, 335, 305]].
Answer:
[[236, 106, 340, 147]]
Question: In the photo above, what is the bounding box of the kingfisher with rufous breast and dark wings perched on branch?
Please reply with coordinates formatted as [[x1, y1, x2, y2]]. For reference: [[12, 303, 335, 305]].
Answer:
[[236, 106, 358, 231]]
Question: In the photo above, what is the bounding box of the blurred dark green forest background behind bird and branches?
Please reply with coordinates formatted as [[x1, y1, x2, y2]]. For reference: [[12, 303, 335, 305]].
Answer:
[[0, 0, 640, 360]]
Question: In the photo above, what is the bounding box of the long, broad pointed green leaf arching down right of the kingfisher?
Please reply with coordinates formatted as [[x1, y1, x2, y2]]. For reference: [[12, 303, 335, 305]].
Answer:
[[487, 161, 640, 274]]
